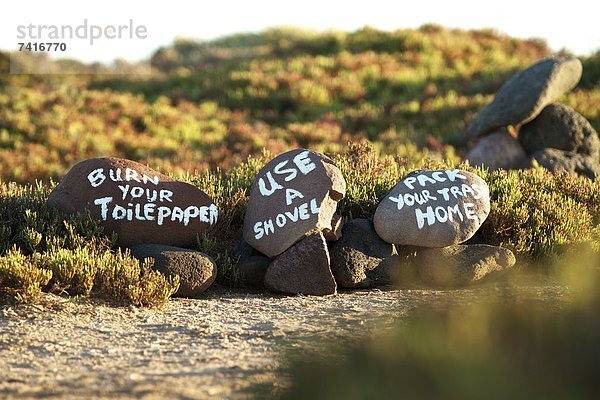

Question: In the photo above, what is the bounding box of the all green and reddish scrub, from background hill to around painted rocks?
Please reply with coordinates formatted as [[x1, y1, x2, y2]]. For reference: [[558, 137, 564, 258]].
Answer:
[[0, 25, 600, 305]]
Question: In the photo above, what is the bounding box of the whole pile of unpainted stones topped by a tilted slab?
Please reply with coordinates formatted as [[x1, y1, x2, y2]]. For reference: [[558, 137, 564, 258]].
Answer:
[[466, 57, 600, 179]]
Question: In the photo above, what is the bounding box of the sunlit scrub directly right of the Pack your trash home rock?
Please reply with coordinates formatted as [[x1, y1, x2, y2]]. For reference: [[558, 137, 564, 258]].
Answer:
[[480, 168, 600, 258]]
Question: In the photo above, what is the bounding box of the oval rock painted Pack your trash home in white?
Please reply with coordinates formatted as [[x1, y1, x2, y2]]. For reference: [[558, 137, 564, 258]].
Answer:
[[373, 170, 490, 247]]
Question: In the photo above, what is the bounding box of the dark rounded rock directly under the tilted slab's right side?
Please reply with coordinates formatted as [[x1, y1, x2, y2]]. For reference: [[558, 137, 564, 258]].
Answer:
[[519, 104, 600, 159]]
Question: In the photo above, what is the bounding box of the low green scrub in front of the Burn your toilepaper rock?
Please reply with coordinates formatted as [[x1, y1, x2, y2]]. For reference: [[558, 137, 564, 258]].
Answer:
[[0, 183, 179, 306]]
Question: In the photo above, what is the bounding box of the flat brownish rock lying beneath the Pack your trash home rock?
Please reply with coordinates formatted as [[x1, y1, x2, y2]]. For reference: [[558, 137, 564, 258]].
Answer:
[[415, 244, 516, 287]]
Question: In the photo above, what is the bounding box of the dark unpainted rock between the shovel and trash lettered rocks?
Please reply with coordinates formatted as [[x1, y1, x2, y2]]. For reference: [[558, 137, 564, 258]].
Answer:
[[329, 218, 394, 288]]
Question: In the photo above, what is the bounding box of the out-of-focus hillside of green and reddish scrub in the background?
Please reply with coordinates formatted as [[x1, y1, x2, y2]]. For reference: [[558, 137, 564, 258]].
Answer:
[[0, 26, 576, 183]]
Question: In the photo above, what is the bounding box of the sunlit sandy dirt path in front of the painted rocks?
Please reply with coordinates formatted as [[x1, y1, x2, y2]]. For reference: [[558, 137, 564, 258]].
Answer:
[[0, 282, 569, 399]]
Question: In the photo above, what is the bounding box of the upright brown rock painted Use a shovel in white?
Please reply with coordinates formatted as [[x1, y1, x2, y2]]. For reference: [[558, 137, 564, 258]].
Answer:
[[243, 149, 346, 258]]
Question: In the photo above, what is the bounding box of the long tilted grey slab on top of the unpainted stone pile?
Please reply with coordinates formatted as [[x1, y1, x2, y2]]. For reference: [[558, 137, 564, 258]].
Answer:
[[467, 57, 583, 137]]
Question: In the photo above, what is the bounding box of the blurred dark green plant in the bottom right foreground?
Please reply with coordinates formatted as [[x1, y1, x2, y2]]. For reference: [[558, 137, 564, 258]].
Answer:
[[282, 253, 600, 400]]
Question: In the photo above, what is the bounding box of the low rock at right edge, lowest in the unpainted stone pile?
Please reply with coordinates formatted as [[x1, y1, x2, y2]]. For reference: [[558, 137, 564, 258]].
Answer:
[[533, 149, 600, 180]]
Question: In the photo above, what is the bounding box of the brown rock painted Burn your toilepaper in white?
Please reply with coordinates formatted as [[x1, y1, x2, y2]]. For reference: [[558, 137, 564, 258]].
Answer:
[[48, 158, 218, 247]]
